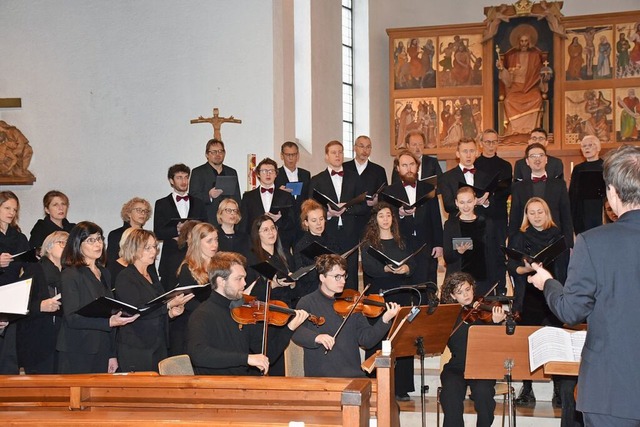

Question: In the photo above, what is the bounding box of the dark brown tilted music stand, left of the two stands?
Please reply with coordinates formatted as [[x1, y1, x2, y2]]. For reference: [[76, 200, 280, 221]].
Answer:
[[388, 304, 460, 427]]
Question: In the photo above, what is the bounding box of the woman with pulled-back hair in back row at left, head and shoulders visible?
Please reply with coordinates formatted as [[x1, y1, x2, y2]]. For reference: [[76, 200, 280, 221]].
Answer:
[[29, 190, 75, 249]]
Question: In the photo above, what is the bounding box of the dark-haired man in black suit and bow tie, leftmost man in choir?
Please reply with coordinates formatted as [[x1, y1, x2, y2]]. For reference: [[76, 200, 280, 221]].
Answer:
[[153, 163, 207, 290]]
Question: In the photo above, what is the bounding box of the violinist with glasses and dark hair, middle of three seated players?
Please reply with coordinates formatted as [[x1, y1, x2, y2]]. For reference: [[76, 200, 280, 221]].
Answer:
[[293, 254, 400, 377]]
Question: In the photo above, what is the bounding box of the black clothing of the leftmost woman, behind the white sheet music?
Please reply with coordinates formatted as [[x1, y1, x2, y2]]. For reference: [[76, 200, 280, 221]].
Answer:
[[0, 226, 29, 375]]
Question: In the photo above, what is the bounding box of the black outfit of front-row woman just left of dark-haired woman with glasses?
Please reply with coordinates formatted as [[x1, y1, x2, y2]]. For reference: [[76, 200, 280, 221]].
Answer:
[[17, 257, 62, 374]]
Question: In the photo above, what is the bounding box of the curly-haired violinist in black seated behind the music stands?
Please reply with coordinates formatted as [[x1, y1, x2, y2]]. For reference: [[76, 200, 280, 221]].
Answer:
[[440, 272, 507, 427]]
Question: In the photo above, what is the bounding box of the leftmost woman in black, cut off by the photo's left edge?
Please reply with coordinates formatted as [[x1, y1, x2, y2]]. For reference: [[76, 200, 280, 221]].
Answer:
[[0, 191, 29, 375]]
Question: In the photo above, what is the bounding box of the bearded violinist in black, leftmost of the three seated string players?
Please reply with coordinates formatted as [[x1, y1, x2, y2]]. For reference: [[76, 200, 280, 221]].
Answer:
[[187, 252, 309, 375]]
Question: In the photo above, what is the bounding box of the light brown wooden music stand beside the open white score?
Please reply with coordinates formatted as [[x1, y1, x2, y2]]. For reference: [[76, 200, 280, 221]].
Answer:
[[464, 325, 549, 427]]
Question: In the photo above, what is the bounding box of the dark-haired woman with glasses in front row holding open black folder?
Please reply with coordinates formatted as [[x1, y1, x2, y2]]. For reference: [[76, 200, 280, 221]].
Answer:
[[56, 221, 139, 374]]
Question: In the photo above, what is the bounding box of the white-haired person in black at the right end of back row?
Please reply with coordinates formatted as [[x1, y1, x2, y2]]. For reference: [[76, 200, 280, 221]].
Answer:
[[569, 135, 605, 234]]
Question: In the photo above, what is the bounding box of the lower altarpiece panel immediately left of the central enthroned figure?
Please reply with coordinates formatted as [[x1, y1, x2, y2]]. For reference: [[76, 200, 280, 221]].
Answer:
[[438, 96, 483, 149]]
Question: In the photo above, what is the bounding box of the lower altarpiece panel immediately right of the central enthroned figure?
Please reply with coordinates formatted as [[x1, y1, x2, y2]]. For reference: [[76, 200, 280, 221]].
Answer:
[[564, 89, 614, 145]]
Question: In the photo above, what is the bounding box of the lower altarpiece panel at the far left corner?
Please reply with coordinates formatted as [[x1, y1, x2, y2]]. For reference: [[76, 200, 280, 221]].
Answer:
[[394, 97, 438, 150]]
